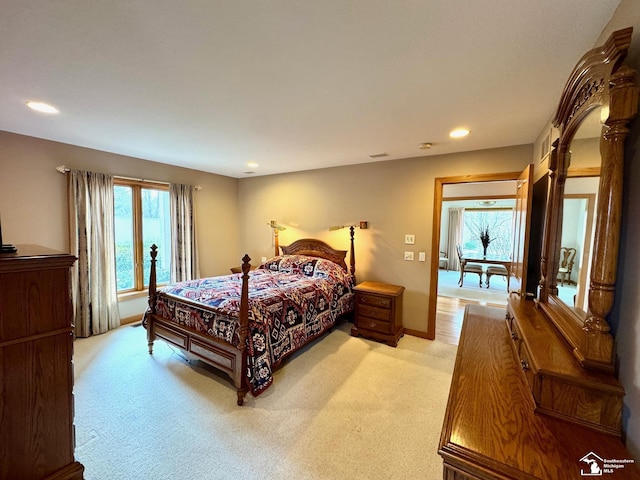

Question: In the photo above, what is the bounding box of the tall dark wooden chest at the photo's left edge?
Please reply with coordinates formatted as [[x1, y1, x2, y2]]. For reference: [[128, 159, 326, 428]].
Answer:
[[0, 245, 84, 480]]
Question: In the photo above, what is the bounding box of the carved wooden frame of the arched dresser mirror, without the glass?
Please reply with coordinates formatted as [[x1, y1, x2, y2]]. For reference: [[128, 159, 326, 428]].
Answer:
[[537, 28, 638, 372]]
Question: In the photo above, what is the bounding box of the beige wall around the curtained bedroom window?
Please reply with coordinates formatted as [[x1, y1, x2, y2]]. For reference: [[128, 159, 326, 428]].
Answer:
[[0, 131, 241, 318]]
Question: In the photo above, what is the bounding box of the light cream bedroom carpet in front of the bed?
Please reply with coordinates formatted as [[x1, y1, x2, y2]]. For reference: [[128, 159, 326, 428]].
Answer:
[[74, 323, 457, 480]]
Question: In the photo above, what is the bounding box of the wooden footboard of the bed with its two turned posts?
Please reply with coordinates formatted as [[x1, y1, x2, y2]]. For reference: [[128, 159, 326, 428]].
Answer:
[[144, 245, 251, 405]]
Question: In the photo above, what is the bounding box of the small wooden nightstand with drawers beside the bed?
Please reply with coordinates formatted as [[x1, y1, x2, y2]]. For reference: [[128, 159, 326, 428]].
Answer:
[[351, 282, 404, 347]]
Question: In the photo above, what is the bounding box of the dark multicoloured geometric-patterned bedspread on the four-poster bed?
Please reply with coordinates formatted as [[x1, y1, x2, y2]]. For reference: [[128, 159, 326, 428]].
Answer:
[[156, 255, 353, 396]]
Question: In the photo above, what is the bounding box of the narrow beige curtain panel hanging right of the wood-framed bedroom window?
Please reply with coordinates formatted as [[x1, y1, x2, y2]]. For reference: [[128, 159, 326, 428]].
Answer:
[[169, 183, 200, 283]]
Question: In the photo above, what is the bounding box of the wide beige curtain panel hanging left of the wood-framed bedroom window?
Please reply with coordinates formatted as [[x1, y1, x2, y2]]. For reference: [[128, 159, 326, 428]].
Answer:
[[68, 170, 120, 337]]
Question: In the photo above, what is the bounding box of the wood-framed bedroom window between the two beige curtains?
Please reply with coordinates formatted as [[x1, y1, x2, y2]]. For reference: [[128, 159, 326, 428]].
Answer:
[[114, 180, 171, 293]]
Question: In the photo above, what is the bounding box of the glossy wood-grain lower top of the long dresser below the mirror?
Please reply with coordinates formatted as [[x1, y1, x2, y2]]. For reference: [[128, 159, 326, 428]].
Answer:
[[438, 305, 640, 480]]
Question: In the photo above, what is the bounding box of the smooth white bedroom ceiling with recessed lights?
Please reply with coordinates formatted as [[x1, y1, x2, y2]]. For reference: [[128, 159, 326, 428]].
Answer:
[[0, 0, 619, 178]]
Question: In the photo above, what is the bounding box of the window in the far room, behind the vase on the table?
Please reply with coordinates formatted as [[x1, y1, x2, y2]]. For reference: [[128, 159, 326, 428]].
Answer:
[[462, 208, 513, 258]]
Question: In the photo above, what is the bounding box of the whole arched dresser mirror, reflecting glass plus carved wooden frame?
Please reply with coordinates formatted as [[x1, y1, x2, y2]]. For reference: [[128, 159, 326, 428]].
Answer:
[[538, 28, 638, 372]]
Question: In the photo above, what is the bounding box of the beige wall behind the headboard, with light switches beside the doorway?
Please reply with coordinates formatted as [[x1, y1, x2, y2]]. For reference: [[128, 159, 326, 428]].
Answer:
[[238, 145, 532, 332]]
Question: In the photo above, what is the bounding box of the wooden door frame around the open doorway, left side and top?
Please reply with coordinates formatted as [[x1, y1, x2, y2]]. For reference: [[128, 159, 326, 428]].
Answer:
[[427, 171, 522, 340]]
